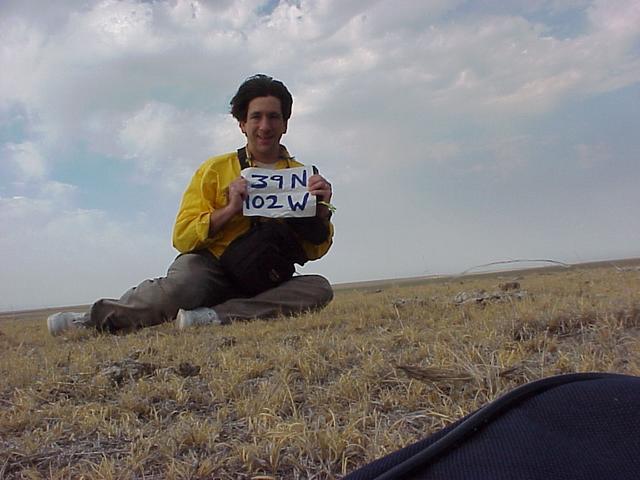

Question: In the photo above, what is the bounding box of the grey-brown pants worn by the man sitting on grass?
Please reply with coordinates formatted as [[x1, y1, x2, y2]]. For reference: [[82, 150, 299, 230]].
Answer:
[[87, 251, 333, 332]]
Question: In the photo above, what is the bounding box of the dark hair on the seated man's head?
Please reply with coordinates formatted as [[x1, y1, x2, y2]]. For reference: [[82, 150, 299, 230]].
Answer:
[[231, 73, 293, 122]]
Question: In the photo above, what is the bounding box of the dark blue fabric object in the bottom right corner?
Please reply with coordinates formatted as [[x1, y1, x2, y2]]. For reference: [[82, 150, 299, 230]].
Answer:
[[344, 373, 640, 480]]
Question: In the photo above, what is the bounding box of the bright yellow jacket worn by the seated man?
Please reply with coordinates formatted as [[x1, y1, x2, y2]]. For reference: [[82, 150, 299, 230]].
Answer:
[[173, 148, 333, 260]]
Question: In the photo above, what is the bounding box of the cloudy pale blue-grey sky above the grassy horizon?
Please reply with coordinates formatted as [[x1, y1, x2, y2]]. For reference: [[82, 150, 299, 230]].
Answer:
[[0, 0, 640, 310]]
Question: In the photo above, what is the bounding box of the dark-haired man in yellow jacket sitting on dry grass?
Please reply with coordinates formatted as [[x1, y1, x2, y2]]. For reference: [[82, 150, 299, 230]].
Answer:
[[47, 75, 333, 335]]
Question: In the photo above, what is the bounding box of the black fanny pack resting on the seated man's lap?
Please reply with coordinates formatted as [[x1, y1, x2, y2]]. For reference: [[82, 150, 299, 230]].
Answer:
[[220, 220, 307, 296]]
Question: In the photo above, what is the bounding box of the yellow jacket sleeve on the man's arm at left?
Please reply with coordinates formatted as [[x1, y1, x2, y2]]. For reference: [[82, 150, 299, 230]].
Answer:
[[173, 166, 222, 253]]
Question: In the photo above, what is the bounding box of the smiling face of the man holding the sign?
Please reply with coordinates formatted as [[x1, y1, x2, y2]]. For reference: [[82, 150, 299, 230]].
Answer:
[[240, 96, 287, 162]]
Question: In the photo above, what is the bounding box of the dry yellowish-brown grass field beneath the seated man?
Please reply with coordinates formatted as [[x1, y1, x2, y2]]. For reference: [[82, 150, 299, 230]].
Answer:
[[0, 261, 640, 480]]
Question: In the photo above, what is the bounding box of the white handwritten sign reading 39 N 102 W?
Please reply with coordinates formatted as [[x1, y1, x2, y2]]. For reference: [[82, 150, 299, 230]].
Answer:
[[241, 166, 316, 218]]
